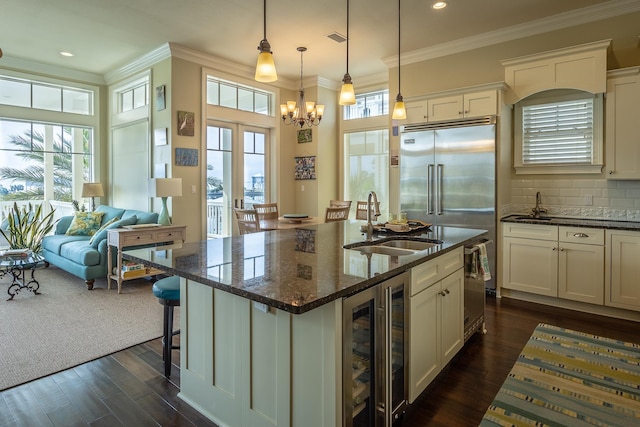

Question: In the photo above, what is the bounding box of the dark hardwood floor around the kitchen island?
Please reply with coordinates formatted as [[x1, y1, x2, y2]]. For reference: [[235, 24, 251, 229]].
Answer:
[[0, 297, 640, 427]]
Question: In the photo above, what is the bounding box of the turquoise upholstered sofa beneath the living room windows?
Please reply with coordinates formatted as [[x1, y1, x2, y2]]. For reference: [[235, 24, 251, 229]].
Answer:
[[42, 205, 158, 289]]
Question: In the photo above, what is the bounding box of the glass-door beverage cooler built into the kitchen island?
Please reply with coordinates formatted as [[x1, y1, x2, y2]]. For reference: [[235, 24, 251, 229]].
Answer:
[[343, 273, 409, 427]]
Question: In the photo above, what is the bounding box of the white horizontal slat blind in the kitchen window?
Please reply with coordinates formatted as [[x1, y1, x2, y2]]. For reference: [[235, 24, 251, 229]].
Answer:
[[522, 98, 594, 165]]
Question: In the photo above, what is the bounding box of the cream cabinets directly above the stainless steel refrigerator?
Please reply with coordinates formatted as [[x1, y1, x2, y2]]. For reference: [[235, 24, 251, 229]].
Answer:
[[407, 90, 498, 123]]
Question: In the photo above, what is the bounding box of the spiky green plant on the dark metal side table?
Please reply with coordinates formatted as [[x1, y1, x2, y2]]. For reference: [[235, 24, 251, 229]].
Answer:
[[0, 202, 55, 253]]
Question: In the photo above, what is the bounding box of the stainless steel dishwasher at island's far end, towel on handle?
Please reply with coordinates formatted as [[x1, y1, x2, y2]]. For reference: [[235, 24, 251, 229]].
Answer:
[[464, 239, 495, 342]]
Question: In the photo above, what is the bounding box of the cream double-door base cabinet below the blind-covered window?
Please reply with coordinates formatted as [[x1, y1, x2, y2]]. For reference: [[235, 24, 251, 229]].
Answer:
[[502, 223, 604, 305]]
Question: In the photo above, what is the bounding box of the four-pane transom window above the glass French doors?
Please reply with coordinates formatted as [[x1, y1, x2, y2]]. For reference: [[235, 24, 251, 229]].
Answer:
[[207, 77, 273, 116]]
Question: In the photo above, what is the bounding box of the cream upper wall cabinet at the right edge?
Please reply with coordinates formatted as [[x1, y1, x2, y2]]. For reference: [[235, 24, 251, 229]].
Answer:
[[605, 67, 640, 179]]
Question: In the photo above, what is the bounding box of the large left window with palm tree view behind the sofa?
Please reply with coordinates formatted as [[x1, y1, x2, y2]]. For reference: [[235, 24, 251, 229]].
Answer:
[[0, 72, 99, 218]]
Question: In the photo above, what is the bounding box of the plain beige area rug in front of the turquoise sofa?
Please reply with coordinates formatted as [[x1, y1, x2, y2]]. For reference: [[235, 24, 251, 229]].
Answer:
[[0, 266, 179, 390]]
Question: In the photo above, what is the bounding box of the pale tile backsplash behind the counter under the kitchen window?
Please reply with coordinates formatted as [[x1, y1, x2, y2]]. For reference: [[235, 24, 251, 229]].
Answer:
[[500, 177, 640, 221]]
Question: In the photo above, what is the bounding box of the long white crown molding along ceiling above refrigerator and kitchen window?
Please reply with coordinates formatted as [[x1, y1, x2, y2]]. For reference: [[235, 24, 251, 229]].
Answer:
[[382, 0, 640, 68]]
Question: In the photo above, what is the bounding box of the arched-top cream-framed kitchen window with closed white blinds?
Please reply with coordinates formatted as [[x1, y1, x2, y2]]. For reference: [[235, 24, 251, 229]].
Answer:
[[514, 90, 602, 174]]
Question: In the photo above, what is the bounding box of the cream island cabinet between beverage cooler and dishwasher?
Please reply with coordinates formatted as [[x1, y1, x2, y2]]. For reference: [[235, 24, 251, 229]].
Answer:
[[408, 248, 464, 403]]
